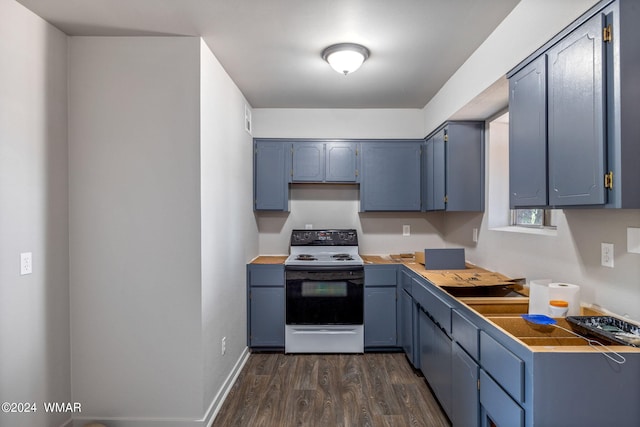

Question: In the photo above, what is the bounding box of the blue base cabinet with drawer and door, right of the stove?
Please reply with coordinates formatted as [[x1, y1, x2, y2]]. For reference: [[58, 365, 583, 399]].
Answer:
[[364, 265, 398, 350]]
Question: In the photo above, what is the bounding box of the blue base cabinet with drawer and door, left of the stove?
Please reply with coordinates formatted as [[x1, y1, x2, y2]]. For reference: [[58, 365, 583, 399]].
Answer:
[[247, 264, 285, 350]]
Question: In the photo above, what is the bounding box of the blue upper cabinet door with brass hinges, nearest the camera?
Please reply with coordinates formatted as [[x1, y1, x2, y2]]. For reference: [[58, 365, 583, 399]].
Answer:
[[547, 14, 606, 206]]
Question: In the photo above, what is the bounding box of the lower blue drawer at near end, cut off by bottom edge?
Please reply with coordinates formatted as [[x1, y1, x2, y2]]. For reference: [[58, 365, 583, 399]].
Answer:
[[480, 369, 524, 427]]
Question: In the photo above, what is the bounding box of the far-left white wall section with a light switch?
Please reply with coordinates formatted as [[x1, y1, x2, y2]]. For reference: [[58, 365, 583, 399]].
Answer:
[[0, 0, 71, 427]]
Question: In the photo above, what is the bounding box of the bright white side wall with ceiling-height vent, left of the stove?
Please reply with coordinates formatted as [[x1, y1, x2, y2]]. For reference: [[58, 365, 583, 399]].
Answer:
[[200, 38, 258, 420]]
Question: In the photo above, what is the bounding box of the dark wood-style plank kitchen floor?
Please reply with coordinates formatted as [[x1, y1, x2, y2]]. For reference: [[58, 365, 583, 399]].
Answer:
[[213, 353, 450, 427]]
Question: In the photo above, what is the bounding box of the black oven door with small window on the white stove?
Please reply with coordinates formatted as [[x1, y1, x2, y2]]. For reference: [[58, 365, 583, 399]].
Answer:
[[285, 266, 364, 325]]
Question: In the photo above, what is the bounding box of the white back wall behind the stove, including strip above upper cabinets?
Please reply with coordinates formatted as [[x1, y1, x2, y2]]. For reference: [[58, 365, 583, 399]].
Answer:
[[253, 109, 444, 255]]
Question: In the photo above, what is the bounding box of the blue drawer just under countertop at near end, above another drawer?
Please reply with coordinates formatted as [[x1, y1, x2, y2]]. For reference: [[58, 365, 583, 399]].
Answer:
[[480, 331, 524, 402]]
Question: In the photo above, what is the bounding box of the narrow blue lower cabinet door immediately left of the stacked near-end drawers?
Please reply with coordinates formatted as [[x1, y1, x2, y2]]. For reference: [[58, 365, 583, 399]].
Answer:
[[451, 344, 480, 427]]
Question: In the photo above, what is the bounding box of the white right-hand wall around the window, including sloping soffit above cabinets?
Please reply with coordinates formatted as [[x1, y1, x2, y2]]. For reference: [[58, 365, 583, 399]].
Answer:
[[424, 0, 640, 320]]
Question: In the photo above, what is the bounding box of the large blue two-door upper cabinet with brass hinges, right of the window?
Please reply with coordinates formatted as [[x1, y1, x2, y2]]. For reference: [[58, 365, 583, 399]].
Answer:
[[507, 0, 640, 208]]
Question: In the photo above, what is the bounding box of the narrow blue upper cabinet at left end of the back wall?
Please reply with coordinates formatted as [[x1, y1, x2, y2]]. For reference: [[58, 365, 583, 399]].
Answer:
[[253, 139, 291, 212]]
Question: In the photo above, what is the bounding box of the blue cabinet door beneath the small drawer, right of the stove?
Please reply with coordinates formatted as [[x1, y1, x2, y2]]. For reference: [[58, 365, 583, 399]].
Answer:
[[364, 286, 397, 348]]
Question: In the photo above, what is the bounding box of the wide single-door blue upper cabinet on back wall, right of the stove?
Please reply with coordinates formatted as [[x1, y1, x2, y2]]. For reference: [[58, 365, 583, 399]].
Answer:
[[360, 140, 422, 212]]
